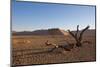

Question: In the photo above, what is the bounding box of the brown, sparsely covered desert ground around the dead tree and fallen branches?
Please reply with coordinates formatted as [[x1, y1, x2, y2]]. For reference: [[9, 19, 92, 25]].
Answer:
[[12, 27, 96, 65]]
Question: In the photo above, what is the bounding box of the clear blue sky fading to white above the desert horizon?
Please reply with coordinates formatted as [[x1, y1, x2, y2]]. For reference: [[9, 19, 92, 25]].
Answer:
[[12, 1, 95, 31]]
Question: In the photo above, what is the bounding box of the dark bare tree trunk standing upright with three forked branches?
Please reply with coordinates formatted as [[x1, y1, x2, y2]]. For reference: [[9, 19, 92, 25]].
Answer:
[[68, 25, 90, 47]]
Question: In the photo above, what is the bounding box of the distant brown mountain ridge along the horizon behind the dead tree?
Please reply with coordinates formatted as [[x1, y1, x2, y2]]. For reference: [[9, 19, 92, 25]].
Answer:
[[12, 28, 95, 35]]
